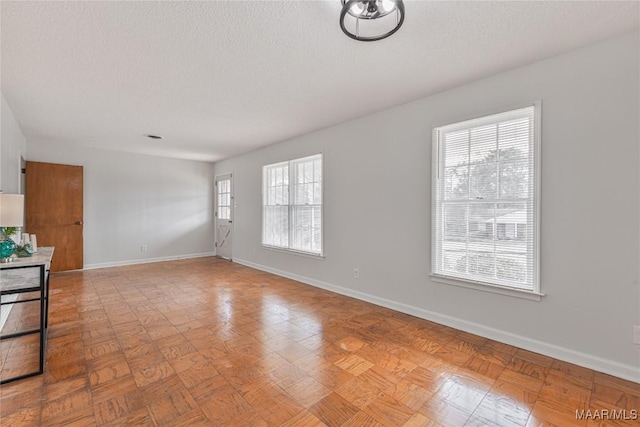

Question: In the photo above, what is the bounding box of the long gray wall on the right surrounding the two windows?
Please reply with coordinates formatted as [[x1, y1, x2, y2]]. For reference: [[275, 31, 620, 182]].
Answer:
[[215, 33, 640, 381]]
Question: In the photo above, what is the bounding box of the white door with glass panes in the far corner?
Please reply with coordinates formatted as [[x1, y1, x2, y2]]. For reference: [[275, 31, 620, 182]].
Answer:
[[215, 173, 233, 260]]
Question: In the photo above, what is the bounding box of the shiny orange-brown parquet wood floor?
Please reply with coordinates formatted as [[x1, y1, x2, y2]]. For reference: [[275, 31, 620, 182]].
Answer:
[[0, 258, 640, 427]]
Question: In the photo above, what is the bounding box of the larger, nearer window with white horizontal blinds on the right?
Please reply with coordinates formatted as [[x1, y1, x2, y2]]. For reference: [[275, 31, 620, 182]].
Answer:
[[432, 105, 540, 293]]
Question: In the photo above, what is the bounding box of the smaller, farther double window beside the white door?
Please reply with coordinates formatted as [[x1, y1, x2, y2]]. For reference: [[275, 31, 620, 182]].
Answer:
[[262, 154, 322, 255]]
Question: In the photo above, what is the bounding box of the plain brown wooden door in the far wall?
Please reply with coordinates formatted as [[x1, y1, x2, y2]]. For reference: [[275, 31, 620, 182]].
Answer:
[[25, 162, 84, 271]]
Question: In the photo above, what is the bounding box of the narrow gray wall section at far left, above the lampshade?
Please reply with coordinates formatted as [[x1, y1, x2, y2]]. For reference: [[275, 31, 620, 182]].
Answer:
[[0, 94, 26, 193]]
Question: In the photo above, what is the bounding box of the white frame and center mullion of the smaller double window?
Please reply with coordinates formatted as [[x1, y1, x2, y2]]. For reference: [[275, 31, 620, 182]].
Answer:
[[260, 152, 324, 259]]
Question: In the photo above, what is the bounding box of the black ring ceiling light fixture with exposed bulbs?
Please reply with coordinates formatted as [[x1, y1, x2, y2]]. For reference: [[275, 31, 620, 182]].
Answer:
[[340, 0, 404, 42]]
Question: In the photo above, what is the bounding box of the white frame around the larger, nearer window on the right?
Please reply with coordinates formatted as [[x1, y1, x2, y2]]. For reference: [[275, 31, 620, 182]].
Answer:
[[430, 100, 544, 301]]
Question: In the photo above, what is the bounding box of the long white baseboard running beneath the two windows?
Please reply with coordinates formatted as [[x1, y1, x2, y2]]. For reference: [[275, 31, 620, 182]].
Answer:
[[233, 258, 640, 383]]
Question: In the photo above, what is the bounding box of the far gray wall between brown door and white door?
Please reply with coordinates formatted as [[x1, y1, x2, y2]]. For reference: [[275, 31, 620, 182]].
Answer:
[[26, 142, 214, 268]]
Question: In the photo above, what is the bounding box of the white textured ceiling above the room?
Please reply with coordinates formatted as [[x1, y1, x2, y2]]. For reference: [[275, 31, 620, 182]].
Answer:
[[0, 0, 639, 161]]
